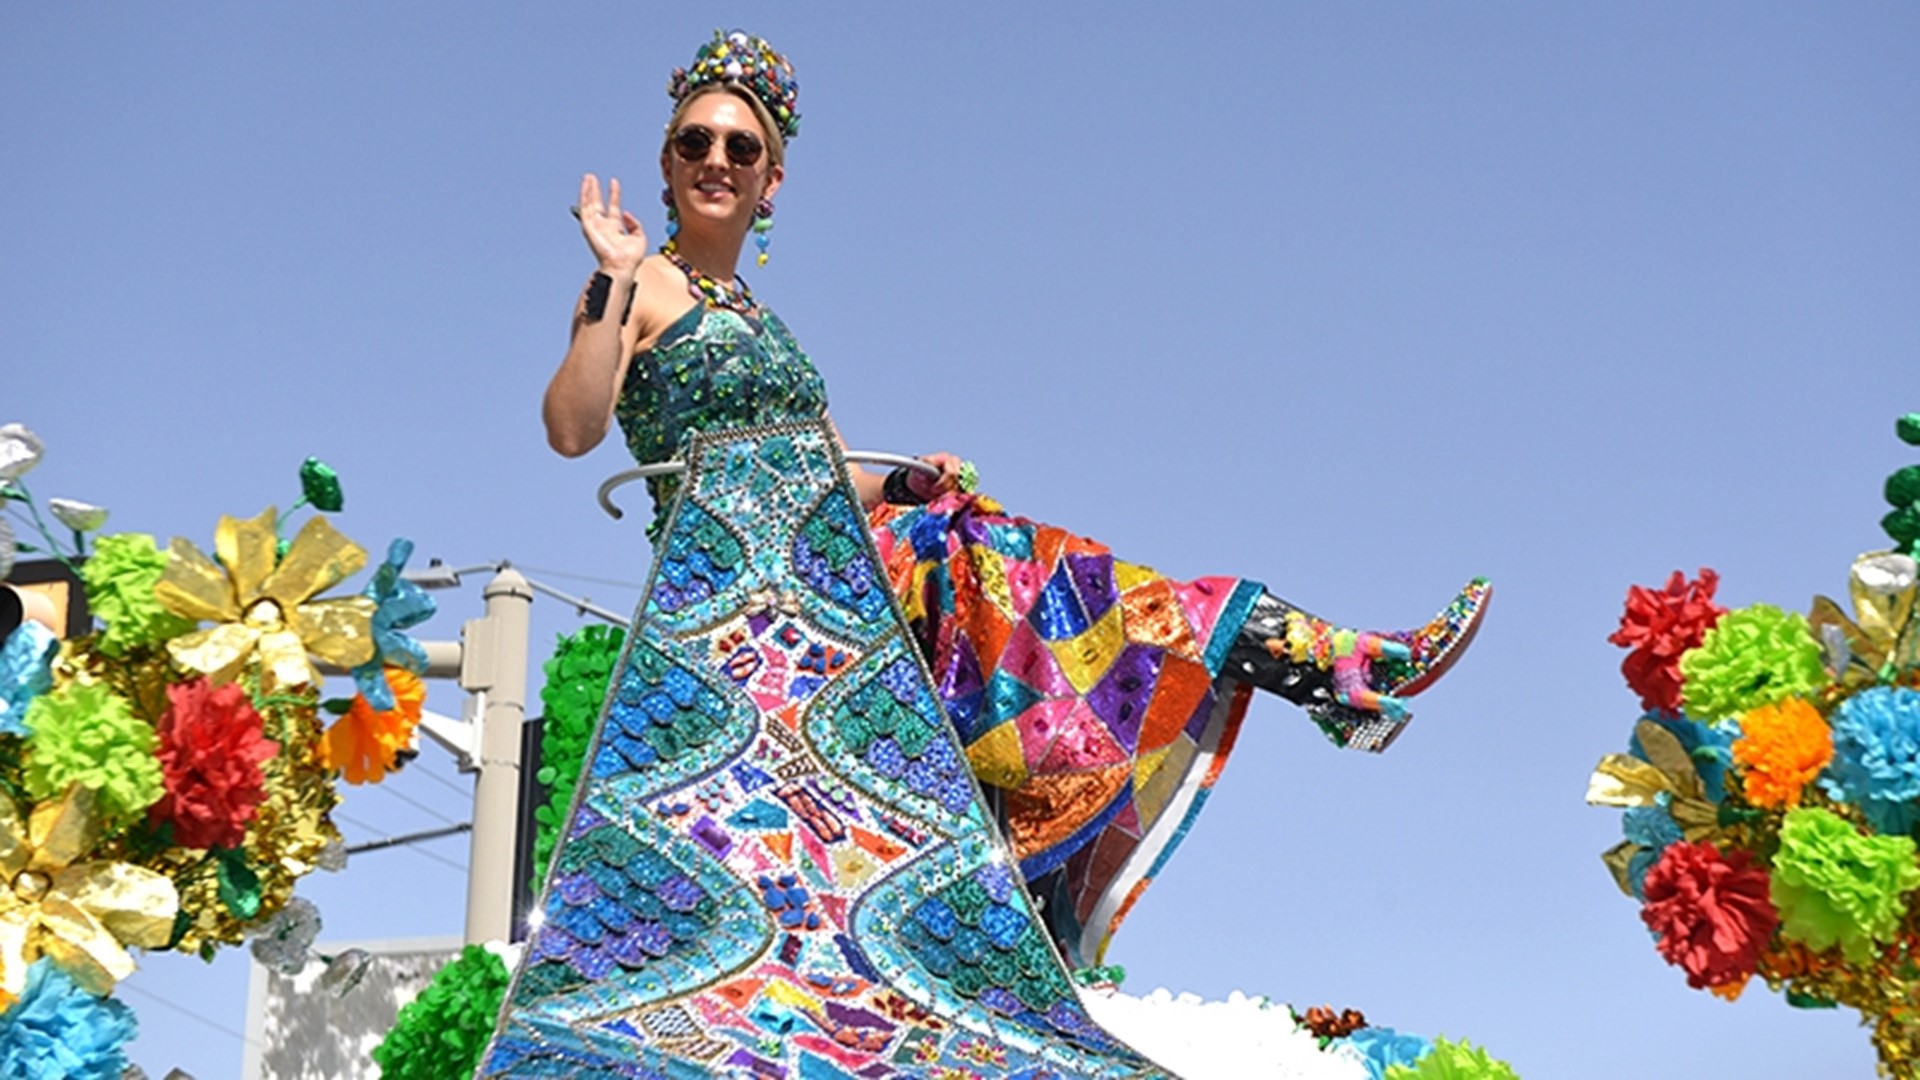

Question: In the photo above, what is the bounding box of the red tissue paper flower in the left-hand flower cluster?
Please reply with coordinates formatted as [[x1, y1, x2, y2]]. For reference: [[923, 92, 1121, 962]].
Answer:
[[154, 678, 280, 847]]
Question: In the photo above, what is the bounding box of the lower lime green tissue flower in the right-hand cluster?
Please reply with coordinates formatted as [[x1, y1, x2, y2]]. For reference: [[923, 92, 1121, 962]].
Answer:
[[1772, 807, 1920, 963]]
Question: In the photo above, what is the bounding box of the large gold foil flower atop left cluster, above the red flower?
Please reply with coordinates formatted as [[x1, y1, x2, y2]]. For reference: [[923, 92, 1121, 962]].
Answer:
[[154, 507, 374, 694]]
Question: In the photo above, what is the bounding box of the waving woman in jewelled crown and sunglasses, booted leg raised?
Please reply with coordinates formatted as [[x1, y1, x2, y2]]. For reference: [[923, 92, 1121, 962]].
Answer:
[[543, 33, 1492, 965]]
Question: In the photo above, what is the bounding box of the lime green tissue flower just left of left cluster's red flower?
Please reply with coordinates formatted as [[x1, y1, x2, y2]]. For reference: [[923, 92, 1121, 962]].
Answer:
[[27, 682, 163, 826]]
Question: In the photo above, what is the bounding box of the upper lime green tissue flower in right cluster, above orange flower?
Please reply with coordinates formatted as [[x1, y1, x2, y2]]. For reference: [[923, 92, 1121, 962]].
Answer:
[[1680, 603, 1828, 721]]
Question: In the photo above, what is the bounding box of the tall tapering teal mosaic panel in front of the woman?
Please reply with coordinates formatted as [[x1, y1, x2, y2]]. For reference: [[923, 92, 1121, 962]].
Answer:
[[480, 423, 1177, 1080]]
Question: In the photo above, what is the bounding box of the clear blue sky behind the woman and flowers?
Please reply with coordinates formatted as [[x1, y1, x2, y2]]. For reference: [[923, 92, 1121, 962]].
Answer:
[[0, 2, 1920, 1080]]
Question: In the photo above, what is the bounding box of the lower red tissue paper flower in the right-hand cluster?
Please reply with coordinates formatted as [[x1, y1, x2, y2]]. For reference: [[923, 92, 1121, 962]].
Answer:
[[1640, 840, 1780, 990]]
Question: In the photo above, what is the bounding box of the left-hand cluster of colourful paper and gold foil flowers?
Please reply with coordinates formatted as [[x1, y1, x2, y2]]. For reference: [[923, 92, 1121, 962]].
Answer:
[[0, 425, 434, 1076]]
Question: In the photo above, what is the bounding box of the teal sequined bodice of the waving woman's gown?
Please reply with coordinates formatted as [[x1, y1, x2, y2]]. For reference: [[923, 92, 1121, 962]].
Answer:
[[614, 304, 828, 540]]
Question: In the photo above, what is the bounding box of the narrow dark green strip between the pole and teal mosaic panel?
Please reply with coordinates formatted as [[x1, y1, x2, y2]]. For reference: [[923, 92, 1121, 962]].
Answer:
[[534, 625, 626, 882]]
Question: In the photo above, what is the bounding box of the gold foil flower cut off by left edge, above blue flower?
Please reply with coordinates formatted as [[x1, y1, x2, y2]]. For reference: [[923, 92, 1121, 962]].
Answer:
[[0, 784, 180, 1005]]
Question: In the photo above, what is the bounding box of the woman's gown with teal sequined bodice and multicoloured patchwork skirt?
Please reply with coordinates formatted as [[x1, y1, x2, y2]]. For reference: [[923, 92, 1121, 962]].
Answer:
[[614, 304, 1263, 965]]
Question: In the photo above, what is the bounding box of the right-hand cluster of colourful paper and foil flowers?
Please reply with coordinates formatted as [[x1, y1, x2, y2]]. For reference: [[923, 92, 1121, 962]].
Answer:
[[1588, 413, 1920, 1078]]
